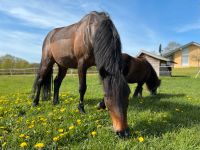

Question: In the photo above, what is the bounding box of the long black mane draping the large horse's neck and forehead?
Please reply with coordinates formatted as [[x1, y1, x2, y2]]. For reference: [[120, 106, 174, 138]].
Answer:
[[94, 14, 130, 98]]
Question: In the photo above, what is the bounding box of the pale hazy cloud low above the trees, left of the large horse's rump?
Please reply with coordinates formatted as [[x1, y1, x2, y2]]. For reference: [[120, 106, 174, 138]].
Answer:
[[0, 30, 43, 62]]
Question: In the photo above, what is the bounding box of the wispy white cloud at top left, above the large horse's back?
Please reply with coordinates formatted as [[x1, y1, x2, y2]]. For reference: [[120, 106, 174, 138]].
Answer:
[[0, 1, 82, 28]]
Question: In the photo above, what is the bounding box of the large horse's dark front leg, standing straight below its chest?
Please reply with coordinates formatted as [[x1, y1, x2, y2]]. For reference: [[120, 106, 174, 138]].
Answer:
[[78, 62, 87, 113]]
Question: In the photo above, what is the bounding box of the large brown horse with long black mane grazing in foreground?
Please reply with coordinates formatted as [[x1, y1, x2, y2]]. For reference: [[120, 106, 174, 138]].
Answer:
[[33, 12, 130, 136]]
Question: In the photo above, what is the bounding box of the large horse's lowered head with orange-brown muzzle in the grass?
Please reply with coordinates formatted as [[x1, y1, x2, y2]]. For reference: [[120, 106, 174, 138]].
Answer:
[[100, 67, 130, 137]]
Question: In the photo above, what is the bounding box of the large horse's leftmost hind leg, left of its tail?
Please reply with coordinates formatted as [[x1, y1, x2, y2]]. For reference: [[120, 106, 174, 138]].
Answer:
[[32, 59, 53, 106]]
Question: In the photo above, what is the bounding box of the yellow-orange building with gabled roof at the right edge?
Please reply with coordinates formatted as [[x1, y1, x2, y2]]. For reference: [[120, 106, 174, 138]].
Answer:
[[163, 42, 200, 68]]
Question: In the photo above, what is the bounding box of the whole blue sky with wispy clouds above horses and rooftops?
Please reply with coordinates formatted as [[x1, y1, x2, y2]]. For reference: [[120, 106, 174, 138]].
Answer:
[[0, 0, 200, 62]]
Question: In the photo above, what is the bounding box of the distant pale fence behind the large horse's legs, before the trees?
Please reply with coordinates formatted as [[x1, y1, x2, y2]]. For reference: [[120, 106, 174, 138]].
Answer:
[[0, 68, 97, 75]]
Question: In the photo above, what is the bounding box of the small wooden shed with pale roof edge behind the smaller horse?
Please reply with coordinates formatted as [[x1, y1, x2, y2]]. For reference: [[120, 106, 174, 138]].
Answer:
[[138, 50, 172, 76]]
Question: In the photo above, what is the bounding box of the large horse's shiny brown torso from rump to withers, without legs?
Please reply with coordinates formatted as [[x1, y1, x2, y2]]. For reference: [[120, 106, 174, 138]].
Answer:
[[43, 12, 108, 68]]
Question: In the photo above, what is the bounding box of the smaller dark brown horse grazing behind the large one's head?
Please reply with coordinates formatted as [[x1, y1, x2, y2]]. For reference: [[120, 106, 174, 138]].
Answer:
[[98, 54, 161, 109]]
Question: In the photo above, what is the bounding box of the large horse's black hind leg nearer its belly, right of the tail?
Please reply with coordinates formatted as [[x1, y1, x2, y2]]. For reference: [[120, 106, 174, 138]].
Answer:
[[53, 66, 67, 105]]
